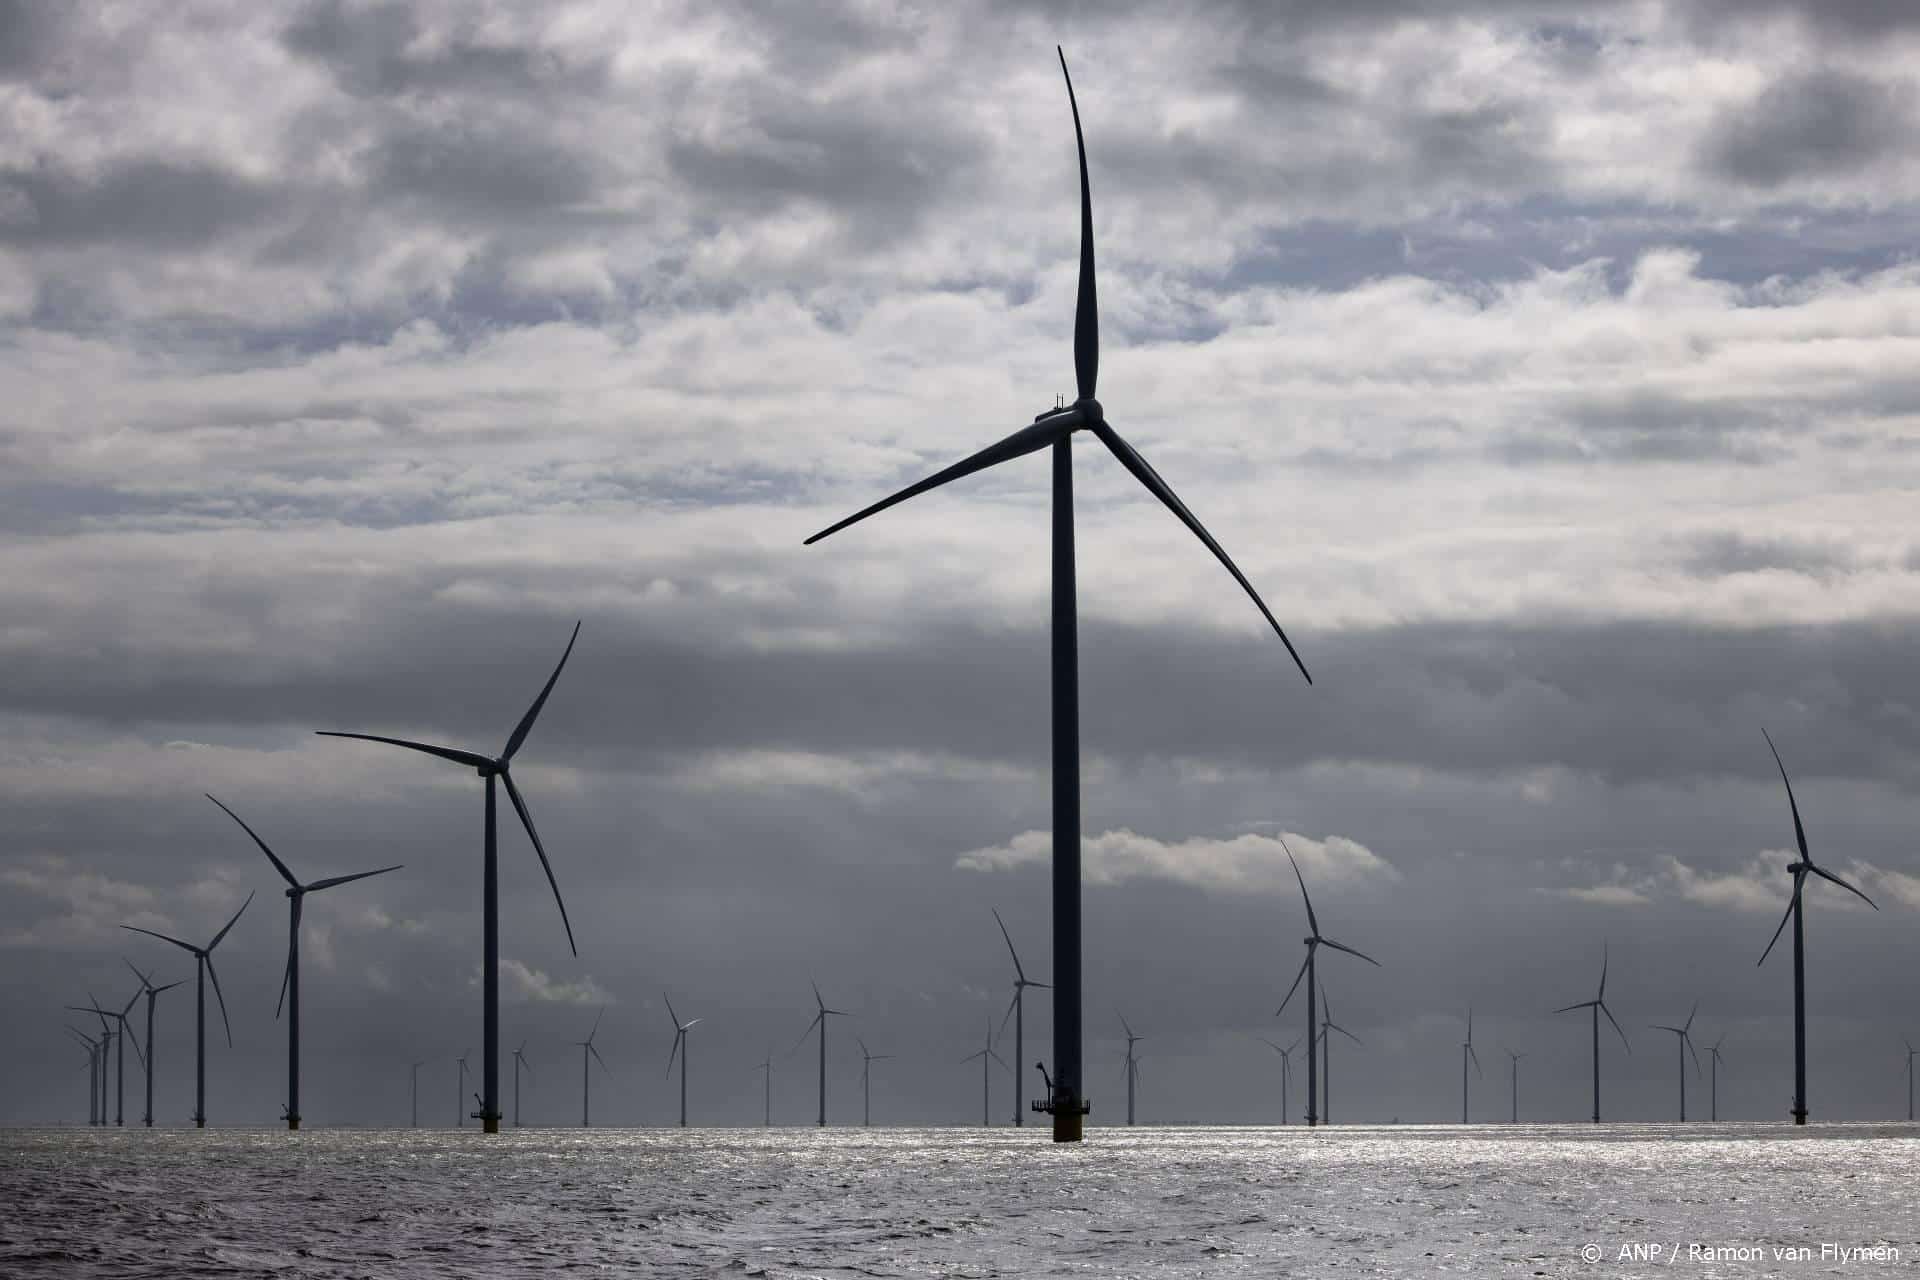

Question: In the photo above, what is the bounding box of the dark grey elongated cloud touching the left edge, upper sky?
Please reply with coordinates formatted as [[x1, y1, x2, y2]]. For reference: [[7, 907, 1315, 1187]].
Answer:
[[0, 159, 292, 249]]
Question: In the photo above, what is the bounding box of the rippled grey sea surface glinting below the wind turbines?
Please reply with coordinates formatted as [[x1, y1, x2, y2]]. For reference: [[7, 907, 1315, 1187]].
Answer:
[[0, 1125, 1920, 1280]]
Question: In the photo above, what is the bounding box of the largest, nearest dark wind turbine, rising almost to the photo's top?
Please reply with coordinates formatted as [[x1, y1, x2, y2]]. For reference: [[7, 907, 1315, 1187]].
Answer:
[[806, 50, 1313, 1142]]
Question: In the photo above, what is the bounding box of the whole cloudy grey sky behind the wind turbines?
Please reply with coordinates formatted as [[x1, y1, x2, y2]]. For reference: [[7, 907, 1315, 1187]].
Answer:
[[0, 0, 1920, 1125]]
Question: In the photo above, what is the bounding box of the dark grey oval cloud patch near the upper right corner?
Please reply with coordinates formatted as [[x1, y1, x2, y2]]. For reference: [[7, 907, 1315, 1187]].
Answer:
[[1705, 69, 1910, 188]]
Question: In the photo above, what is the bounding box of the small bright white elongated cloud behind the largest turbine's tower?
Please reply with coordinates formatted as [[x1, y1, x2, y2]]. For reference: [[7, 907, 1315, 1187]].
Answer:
[[954, 829, 1400, 894]]
